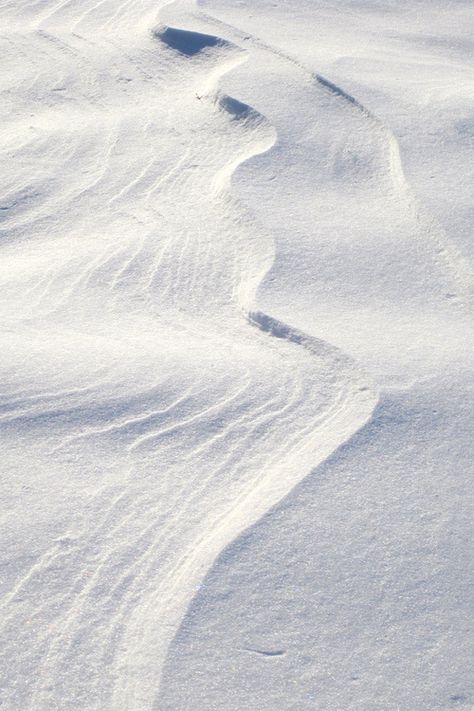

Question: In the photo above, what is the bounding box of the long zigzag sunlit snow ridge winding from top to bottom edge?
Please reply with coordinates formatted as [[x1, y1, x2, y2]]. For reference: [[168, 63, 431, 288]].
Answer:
[[144, 6, 378, 711]]
